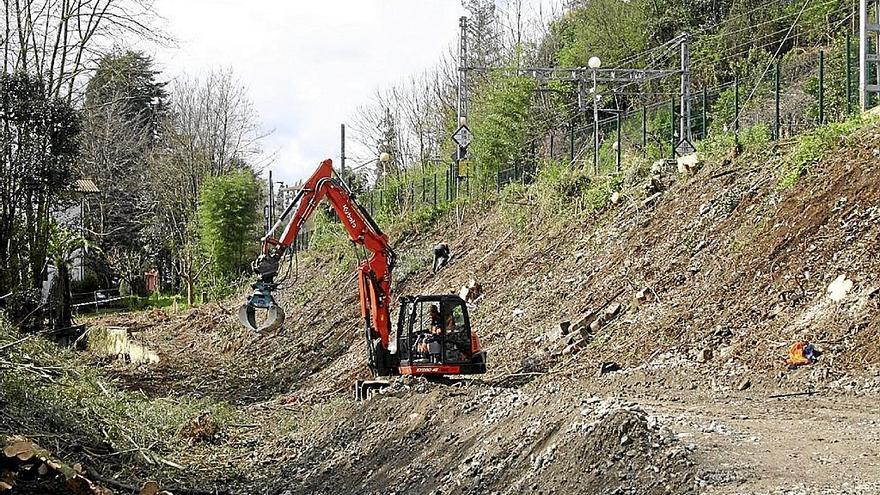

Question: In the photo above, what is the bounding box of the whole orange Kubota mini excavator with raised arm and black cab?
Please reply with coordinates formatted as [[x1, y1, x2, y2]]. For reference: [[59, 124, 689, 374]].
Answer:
[[239, 160, 486, 392]]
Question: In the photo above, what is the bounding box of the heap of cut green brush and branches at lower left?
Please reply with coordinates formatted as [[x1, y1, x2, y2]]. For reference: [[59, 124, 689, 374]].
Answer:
[[0, 320, 239, 473]]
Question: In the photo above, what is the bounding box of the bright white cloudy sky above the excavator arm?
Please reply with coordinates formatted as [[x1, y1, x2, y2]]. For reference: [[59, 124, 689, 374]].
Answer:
[[152, 0, 464, 183]]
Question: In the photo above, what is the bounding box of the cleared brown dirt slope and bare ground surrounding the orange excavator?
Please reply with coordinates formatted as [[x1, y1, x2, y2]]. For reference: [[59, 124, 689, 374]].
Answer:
[[6, 119, 880, 494]]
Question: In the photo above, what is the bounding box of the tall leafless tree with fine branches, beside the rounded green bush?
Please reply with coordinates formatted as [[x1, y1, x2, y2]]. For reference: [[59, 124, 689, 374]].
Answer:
[[148, 70, 265, 302]]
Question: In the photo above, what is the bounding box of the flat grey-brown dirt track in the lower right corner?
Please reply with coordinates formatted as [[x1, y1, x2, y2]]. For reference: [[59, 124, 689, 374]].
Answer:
[[642, 396, 880, 494]]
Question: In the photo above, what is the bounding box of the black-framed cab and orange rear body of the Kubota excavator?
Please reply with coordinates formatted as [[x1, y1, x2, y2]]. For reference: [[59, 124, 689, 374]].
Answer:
[[397, 294, 486, 375]]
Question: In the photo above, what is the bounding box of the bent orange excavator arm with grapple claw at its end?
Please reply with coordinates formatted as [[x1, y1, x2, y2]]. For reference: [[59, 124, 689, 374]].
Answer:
[[239, 159, 395, 375]]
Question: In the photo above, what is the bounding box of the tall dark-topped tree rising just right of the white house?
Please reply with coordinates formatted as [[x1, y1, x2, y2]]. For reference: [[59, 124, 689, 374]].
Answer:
[[78, 51, 168, 290]]
